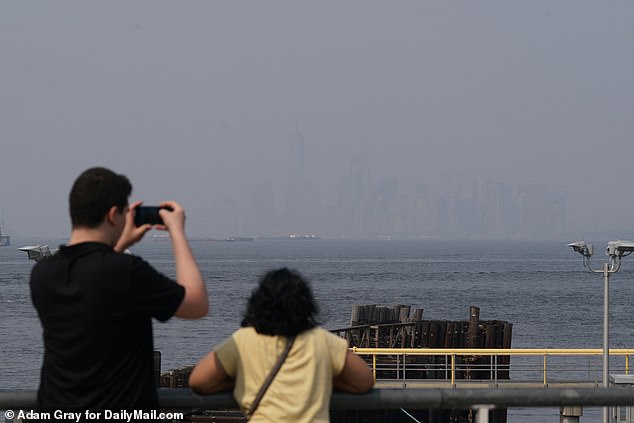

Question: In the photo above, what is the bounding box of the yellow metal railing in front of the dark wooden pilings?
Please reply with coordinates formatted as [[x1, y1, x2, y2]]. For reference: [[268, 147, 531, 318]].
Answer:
[[352, 347, 634, 387]]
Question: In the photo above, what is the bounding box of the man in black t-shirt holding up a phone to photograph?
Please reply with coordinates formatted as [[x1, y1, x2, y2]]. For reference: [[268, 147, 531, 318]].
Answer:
[[30, 168, 208, 418]]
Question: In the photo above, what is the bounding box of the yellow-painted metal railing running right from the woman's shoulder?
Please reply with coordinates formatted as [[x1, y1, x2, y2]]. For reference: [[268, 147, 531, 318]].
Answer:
[[351, 347, 634, 387]]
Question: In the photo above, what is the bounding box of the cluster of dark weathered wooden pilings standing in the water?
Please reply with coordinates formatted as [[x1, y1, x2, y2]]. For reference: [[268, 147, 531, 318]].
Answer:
[[331, 304, 513, 380]]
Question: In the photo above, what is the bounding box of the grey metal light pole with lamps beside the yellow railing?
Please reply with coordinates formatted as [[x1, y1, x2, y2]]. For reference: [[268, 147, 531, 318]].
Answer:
[[568, 240, 634, 423]]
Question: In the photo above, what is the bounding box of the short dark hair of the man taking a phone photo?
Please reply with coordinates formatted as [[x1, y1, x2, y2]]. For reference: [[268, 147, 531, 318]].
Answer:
[[69, 167, 132, 228]]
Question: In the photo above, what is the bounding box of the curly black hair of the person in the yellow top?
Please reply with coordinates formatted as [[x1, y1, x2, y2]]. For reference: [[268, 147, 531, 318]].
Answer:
[[242, 268, 318, 336]]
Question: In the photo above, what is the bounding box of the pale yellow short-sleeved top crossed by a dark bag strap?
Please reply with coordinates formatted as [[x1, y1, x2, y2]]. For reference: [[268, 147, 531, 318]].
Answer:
[[215, 327, 348, 423]]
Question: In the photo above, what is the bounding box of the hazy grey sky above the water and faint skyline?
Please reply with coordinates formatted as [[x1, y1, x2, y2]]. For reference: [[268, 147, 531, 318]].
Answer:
[[0, 0, 634, 242]]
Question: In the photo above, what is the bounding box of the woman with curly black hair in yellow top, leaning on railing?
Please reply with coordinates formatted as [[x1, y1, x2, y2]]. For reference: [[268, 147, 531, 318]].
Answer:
[[189, 268, 374, 422]]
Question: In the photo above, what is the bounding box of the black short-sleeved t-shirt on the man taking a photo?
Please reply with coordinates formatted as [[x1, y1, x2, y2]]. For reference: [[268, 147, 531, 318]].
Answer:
[[30, 242, 185, 410]]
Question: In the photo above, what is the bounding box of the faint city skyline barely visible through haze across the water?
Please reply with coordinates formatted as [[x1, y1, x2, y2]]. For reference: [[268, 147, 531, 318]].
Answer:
[[207, 149, 567, 239]]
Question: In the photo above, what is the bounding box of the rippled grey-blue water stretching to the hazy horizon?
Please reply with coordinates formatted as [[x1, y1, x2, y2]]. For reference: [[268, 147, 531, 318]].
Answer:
[[0, 238, 634, 422]]
